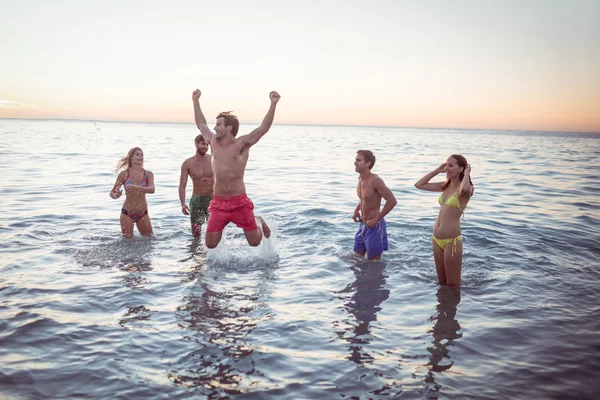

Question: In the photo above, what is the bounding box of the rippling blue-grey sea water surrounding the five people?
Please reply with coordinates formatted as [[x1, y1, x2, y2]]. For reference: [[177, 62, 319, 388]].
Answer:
[[0, 120, 600, 399]]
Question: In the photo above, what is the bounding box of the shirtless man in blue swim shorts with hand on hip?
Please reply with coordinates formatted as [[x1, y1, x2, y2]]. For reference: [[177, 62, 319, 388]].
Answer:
[[352, 150, 398, 260]]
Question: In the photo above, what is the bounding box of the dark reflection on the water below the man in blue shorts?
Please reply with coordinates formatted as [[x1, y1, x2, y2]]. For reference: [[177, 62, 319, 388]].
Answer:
[[334, 262, 390, 364]]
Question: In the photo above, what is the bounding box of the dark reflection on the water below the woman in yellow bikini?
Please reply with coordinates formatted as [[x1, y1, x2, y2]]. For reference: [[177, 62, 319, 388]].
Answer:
[[425, 286, 462, 392]]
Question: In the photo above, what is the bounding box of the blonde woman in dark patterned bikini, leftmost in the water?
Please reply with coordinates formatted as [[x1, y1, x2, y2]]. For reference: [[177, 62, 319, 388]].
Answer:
[[110, 147, 154, 238]]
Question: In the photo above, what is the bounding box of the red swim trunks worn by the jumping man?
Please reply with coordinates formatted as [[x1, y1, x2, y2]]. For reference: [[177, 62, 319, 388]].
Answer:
[[206, 193, 258, 232]]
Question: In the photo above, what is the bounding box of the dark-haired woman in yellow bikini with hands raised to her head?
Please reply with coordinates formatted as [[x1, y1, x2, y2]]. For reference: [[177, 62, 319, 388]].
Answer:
[[415, 154, 474, 286]]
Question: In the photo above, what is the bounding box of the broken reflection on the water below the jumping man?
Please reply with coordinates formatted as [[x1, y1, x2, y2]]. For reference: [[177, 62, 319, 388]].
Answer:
[[169, 264, 273, 396]]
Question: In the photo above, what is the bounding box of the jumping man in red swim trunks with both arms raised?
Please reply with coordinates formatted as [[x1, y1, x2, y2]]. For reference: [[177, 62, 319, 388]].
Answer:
[[192, 89, 280, 249]]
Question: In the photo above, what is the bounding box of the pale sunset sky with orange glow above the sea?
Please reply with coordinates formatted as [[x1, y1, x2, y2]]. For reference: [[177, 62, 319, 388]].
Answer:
[[0, 0, 600, 132]]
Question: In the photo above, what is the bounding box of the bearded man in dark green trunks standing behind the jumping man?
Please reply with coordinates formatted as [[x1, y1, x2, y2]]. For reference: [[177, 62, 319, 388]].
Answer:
[[179, 135, 215, 237]]
